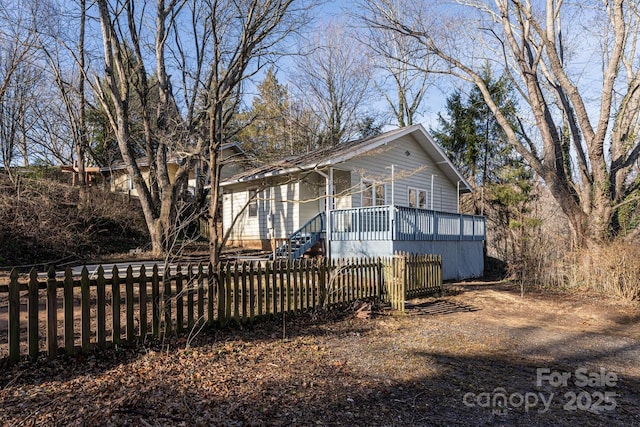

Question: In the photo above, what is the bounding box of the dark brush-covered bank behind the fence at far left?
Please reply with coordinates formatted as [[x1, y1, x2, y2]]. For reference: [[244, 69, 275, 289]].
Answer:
[[0, 169, 148, 268]]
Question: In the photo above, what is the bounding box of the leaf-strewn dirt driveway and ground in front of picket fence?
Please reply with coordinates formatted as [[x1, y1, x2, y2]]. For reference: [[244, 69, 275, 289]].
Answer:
[[0, 283, 640, 426]]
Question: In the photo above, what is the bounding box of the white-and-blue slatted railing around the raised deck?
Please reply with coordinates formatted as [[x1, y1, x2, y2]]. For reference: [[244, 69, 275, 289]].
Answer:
[[330, 205, 485, 241]]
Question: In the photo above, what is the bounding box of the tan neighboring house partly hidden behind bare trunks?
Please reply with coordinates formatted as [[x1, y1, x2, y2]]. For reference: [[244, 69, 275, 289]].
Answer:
[[100, 143, 249, 196]]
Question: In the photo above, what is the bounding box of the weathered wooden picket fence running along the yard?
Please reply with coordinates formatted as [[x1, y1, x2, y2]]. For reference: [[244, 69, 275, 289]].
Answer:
[[0, 254, 442, 363]]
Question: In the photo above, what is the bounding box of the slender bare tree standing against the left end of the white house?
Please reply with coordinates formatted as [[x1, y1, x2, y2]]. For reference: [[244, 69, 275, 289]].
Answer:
[[198, 0, 312, 263]]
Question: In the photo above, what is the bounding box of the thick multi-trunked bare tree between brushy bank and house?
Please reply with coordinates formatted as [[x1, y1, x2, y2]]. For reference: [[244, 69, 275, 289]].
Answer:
[[93, 0, 199, 254]]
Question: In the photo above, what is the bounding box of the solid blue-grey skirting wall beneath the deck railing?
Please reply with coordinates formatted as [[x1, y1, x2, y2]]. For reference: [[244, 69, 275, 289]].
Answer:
[[330, 240, 484, 280]]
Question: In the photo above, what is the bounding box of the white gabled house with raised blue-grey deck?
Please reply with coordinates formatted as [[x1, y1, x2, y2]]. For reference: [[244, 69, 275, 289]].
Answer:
[[221, 125, 485, 279]]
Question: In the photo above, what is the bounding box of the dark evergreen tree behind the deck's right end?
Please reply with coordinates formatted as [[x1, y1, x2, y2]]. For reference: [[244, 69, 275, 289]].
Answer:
[[432, 68, 541, 277]]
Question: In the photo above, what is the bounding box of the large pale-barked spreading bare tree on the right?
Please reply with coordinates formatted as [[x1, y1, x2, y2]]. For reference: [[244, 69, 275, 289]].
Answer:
[[364, 0, 640, 244]]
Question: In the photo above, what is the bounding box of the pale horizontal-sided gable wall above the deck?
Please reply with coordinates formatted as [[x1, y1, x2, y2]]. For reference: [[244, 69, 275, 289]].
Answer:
[[341, 135, 458, 212]]
